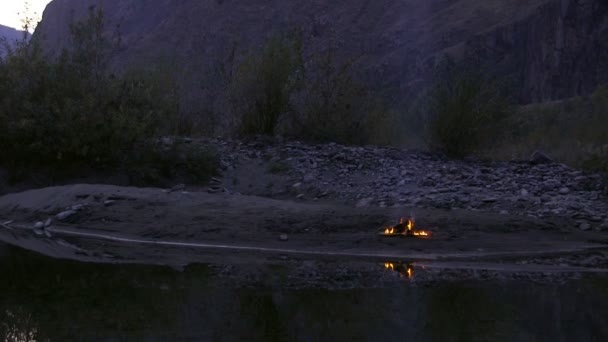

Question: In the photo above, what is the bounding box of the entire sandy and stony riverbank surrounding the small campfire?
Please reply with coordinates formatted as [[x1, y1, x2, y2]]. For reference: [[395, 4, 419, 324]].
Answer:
[[0, 139, 608, 287]]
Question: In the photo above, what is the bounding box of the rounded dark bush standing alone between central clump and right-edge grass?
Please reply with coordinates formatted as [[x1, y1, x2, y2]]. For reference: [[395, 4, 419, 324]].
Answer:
[[429, 60, 509, 158]]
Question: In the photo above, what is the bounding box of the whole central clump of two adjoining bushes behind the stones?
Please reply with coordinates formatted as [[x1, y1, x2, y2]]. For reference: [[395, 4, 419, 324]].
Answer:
[[228, 35, 392, 144]]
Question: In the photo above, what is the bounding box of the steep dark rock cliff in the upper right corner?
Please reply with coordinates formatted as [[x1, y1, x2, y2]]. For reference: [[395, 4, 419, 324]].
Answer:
[[465, 0, 608, 103]]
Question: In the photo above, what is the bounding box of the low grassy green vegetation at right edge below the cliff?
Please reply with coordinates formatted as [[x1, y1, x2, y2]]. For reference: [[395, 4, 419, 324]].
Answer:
[[491, 85, 608, 172]]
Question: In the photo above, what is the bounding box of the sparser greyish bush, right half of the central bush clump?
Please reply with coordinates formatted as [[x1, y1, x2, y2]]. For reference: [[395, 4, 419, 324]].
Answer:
[[289, 50, 389, 145]]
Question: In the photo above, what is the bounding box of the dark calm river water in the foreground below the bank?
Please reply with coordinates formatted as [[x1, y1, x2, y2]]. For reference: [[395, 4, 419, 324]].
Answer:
[[0, 246, 608, 341]]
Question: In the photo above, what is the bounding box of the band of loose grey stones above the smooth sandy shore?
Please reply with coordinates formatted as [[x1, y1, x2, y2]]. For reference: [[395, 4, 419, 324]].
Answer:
[[195, 138, 608, 230]]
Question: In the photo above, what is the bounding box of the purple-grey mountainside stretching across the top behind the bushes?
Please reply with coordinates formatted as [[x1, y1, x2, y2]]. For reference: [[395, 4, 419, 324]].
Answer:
[[36, 0, 608, 103]]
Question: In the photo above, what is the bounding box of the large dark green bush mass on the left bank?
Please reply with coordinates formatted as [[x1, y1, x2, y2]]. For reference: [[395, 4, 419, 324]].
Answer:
[[0, 8, 214, 183]]
